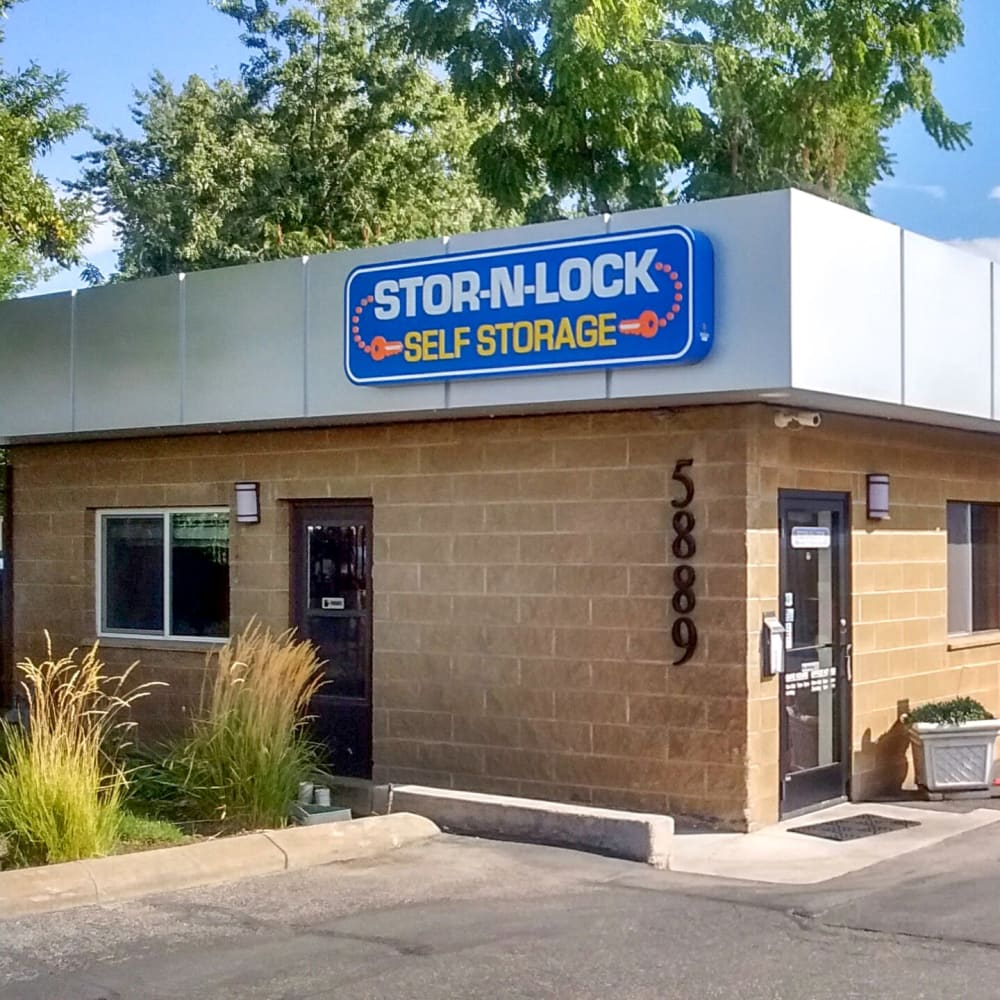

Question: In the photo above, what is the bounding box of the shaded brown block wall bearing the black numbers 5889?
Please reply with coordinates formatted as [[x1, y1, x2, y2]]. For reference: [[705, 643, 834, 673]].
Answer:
[[7, 407, 752, 826]]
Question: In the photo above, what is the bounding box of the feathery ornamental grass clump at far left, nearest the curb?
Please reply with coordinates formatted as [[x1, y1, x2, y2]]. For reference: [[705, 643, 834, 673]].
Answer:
[[0, 633, 154, 864]]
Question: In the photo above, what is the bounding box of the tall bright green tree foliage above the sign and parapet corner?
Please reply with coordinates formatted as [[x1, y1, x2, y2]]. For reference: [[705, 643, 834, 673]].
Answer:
[[407, 0, 968, 217]]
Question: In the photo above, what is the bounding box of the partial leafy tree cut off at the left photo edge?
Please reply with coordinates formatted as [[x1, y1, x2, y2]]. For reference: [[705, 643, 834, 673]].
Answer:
[[0, 0, 91, 299]]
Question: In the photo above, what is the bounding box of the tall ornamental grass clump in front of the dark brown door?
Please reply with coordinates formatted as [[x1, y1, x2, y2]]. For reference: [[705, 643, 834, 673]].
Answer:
[[168, 622, 322, 830]]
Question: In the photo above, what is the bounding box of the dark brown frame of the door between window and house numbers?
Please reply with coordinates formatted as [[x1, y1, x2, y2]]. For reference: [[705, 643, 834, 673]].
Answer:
[[287, 497, 375, 778]]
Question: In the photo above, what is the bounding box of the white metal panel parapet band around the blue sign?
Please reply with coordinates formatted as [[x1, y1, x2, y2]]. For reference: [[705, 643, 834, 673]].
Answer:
[[0, 191, 1000, 444]]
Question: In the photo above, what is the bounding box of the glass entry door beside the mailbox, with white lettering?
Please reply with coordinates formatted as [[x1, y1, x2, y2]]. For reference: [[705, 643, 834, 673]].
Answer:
[[779, 491, 851, 815]]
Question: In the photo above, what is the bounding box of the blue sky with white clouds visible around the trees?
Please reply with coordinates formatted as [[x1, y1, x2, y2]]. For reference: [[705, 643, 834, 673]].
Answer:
[[0, 0, 1000, 291]]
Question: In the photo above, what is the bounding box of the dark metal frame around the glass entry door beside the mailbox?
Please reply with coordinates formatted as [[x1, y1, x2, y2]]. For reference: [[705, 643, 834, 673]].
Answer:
[[778, 490, 854, 817]]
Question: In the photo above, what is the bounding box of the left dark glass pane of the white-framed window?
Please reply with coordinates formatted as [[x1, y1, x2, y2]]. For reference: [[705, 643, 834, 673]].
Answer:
[[103, 515, 163, 634]]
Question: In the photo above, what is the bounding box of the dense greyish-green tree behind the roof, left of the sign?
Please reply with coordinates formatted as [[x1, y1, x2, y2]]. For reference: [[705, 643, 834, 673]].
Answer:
[[81, 0, 514, 278]]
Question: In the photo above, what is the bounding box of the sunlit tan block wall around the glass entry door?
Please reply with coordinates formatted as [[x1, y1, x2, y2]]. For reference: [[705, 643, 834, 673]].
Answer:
[[747, 407, 1000, 825]]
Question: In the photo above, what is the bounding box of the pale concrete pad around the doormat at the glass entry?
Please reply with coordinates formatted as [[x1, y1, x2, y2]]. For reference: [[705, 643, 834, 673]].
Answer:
[[670, 802, 1000, 885]]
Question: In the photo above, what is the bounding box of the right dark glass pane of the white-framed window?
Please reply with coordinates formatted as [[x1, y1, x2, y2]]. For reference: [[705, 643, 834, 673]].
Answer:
[[170, 512, 229, 639]]
